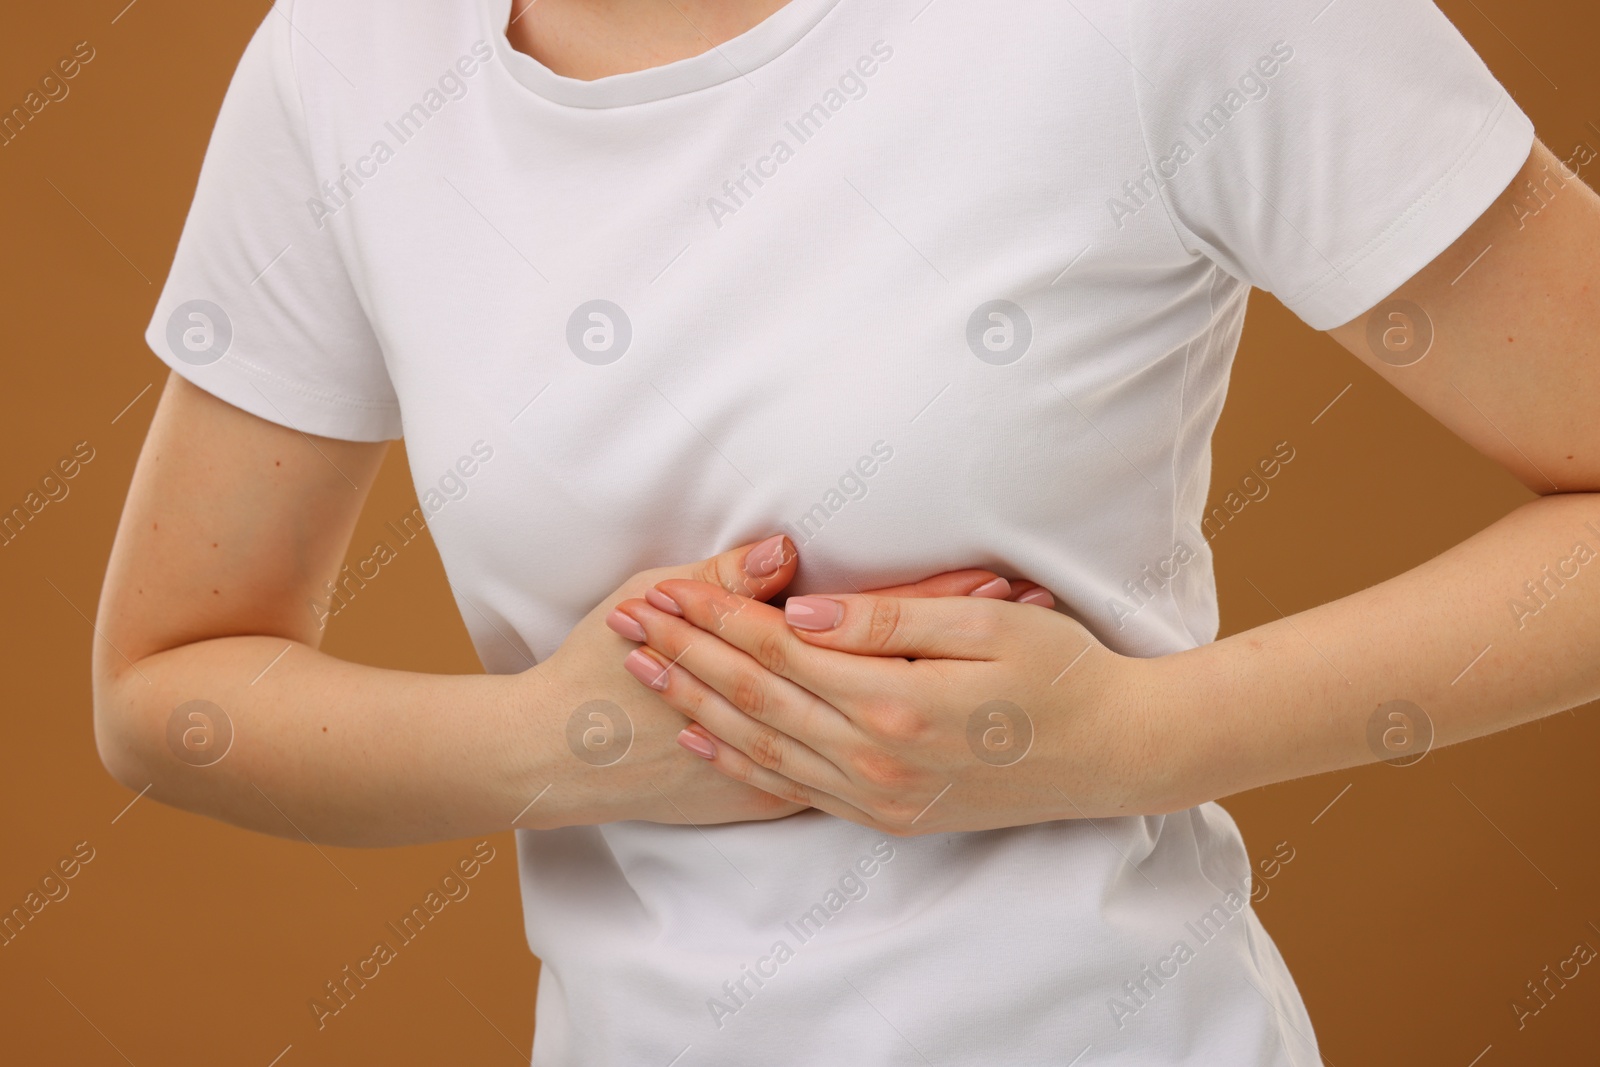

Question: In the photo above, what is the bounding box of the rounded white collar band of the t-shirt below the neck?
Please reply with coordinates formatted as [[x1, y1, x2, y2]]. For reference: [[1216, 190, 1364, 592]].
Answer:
[[478, 0, 838, 107]]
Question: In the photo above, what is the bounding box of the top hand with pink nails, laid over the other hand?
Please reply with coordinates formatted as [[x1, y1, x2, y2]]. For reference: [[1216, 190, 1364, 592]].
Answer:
[[613, 581, 1197, 837]]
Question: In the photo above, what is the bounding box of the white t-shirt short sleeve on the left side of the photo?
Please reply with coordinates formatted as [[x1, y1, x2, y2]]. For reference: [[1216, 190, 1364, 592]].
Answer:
[[144, 8, 400, 442]]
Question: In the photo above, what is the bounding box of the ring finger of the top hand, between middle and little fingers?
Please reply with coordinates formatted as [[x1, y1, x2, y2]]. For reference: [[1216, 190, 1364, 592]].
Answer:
[[622, 639, 850, 803]]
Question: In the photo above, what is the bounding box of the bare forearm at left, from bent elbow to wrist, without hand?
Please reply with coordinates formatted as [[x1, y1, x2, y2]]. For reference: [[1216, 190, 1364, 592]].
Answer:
[[94, 637, 540, 846]]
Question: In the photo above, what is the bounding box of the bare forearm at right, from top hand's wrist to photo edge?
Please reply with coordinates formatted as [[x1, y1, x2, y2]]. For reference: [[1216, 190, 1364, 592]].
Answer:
[[1149, 493, 1600, 803]]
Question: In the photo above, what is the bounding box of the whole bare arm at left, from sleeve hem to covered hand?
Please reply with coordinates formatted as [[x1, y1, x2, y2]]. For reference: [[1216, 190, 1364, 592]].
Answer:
[[94, 374, 812, 845]]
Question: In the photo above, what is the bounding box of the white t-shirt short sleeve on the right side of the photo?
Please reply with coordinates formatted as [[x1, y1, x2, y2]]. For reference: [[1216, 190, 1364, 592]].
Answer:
[[1128, 0, 1533, 330]]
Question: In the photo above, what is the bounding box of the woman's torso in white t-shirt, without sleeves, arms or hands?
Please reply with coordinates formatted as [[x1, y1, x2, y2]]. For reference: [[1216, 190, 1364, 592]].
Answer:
[[219, 0, 1314, 1067]]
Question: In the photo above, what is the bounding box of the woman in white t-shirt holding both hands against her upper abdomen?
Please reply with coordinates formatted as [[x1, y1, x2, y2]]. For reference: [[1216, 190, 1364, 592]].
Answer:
[[96, 0, 1600, 1067]]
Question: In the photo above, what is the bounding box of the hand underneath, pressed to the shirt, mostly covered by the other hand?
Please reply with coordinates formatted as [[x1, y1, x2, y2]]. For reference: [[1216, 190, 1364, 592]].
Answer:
[[515, 536, 1037, 829]]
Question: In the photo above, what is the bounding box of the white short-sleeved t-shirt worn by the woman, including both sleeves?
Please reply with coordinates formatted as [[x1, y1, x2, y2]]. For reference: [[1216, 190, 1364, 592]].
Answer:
[[146, 0, 1533, 1067]]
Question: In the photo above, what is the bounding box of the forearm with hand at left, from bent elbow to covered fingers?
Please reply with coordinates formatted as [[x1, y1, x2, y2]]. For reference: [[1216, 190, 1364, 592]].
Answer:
[[94, 537, 838, 846]]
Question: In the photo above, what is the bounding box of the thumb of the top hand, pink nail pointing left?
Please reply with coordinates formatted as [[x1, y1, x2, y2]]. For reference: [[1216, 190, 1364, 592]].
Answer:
[[784, 595, 1016, 659]]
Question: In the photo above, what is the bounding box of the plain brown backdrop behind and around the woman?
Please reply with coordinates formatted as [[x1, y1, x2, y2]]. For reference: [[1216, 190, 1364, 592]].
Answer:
[[0, 0, 1600, 1067]]
